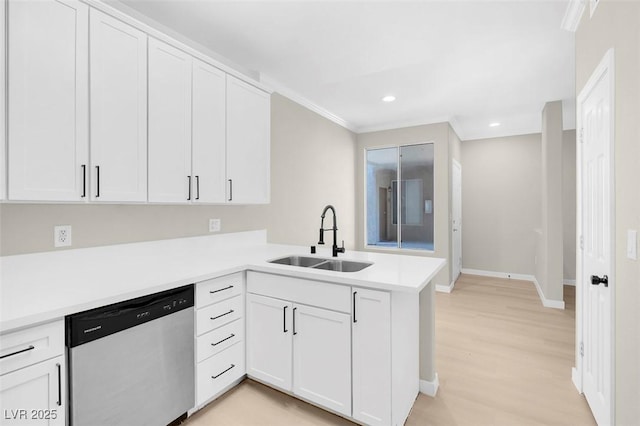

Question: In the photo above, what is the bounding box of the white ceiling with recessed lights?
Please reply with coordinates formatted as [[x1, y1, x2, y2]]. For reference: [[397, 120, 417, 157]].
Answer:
[[111, 0, 575, 140]]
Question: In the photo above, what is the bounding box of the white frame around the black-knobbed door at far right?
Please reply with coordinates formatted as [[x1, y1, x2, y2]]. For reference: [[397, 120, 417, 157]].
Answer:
[[571, 48, 616, 424]]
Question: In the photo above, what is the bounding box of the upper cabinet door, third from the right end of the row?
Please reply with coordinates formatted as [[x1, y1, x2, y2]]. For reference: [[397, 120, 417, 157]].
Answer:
[[149, 38, 193, 203]]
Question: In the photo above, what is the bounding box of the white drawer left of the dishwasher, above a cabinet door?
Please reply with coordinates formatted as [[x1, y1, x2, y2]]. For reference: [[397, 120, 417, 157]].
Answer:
[[0, 319, 64, 374]]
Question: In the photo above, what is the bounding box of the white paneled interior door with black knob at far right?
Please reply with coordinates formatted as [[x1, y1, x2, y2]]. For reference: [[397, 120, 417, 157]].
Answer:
[[578, 47, 615, 425]]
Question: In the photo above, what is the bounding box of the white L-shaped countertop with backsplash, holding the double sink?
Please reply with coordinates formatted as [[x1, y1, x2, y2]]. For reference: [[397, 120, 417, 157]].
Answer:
[[0, 231, 446, 333]]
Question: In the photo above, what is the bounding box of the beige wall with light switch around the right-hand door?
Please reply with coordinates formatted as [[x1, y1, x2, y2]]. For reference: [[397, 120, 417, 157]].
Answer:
[[576, 0, 640, 425]]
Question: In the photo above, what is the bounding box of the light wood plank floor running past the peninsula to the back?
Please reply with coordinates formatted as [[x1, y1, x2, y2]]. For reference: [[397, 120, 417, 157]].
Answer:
[[184, 275, 595, 426]]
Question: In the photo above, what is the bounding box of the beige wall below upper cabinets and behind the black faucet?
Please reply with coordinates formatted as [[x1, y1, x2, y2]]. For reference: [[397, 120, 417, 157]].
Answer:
[[0, 94, 355, 256]]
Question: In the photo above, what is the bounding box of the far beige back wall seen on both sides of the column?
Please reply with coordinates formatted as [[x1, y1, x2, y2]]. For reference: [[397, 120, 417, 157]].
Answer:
[[462, 130, 576, 280]]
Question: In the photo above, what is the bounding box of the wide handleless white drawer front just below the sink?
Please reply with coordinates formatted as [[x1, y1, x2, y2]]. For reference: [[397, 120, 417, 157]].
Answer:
[[247, 271, 351, 313]]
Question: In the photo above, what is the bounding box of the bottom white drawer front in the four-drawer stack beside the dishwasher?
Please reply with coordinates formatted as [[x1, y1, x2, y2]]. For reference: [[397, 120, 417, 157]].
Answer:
[[196, 342, 245, 405]]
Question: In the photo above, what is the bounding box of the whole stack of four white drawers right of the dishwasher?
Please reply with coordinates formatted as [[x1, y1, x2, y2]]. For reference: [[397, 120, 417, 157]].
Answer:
[[196, 272, 246, 408]]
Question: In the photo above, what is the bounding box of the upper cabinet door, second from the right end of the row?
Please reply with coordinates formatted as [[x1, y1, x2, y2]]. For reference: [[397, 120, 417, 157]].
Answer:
[[192, 59, 226, 203]]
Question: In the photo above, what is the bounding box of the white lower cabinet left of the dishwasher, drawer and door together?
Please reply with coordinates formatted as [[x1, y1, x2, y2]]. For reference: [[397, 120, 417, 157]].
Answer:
[[0, 320, 67, 426]]
